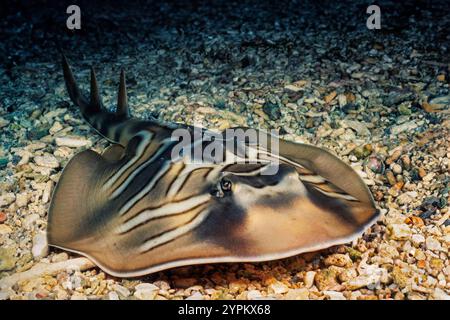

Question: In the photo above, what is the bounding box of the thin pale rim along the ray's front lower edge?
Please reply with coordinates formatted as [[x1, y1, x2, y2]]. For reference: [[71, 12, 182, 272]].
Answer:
[[49, 210, 380, 278]]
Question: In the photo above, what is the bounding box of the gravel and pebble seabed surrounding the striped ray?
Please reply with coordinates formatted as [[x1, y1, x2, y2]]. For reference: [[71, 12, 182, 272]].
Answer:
[[0, 1, 450, 300]]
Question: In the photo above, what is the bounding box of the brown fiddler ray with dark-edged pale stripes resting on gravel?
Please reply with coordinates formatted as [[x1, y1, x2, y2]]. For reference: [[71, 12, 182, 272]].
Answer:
[[47, 57, 379, 277]]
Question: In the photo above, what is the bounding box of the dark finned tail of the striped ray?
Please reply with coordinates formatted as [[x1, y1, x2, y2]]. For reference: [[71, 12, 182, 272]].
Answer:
[[62, 54, 139, 145]]
